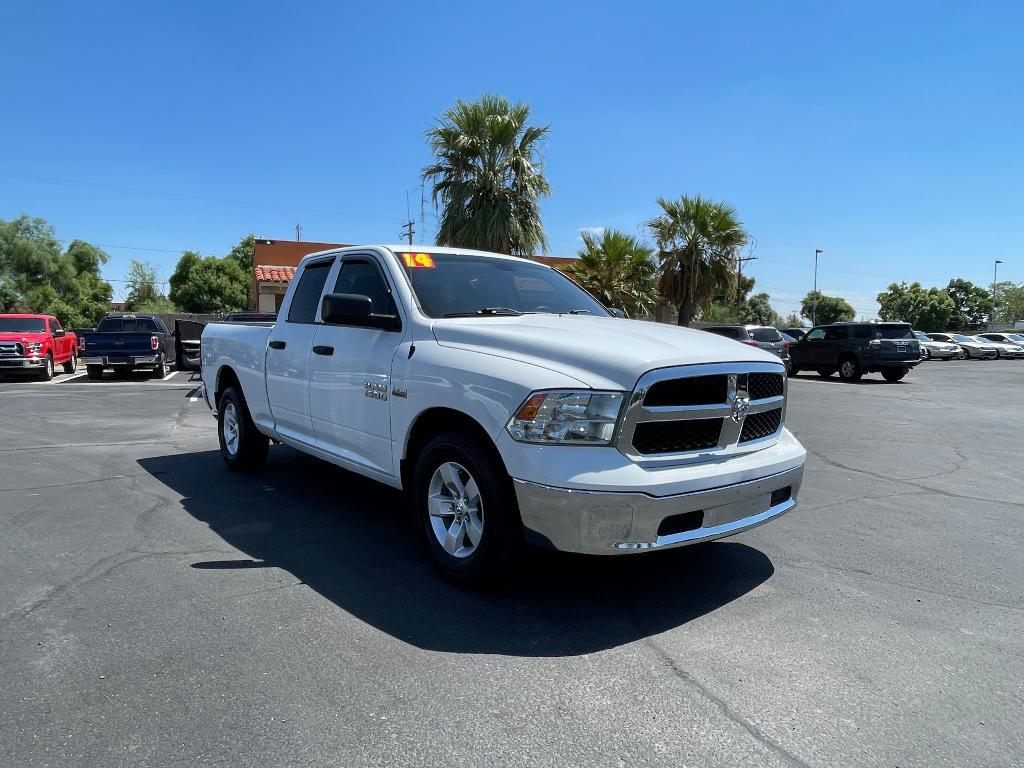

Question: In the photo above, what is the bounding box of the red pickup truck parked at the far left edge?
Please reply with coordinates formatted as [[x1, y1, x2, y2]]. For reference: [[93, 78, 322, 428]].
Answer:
[[0, 314, 78, 381]]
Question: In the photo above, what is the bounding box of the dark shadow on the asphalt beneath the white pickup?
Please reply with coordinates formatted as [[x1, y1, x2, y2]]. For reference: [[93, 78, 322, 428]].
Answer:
[[138, 446, 774, 656]]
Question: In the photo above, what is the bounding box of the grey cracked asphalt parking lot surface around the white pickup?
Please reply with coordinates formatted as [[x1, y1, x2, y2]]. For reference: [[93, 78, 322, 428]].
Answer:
[[0, 361, 1024, 768]]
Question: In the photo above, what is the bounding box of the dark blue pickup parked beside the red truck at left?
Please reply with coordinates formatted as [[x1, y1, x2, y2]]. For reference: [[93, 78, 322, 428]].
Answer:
[[82, 314, 174, 379]]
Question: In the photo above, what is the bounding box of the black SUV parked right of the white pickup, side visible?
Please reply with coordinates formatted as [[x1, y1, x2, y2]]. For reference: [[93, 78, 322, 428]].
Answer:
[[790, 323, 921, 382]]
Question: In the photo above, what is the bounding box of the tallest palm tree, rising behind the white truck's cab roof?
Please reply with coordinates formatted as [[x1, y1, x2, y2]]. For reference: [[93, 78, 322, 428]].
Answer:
[[422, 94, 551, 256]]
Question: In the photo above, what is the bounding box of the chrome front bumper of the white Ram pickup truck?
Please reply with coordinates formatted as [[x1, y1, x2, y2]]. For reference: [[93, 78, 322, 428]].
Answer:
[[514, 466, 804, 555]]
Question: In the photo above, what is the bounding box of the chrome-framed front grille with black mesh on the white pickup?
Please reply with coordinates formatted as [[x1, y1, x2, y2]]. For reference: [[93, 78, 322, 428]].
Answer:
[[617, 362, 787, 462]]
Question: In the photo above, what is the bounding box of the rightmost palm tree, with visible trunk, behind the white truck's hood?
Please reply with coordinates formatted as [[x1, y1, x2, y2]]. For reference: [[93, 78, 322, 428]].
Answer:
[[647, 195, 748, 326]]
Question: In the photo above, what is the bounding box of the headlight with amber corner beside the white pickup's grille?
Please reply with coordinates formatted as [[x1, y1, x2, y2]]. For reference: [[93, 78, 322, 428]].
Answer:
[[506, 390, 624, 445]]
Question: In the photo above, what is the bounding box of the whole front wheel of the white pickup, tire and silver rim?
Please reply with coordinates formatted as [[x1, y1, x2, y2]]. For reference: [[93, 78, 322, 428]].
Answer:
[[413, 432, 522, 586]]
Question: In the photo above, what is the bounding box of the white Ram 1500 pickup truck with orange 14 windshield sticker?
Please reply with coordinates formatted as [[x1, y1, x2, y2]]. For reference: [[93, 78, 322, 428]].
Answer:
[[202, 246, 806, 581]]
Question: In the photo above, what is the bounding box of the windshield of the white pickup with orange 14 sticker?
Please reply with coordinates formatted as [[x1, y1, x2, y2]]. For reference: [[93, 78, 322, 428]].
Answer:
[[397, 253, 610, 317]]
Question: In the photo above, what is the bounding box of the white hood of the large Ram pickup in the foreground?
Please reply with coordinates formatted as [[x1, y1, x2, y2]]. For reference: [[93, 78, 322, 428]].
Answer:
[[433, 314, 781, 390]]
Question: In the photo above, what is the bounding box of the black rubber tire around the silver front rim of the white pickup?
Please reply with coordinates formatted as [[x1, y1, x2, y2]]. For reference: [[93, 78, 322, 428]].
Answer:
[[412, 432, 523, 587]]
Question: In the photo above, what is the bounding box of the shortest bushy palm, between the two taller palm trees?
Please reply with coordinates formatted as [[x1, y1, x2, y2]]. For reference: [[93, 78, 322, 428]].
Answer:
[[565, 229, 657, 316]]
